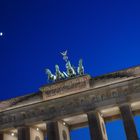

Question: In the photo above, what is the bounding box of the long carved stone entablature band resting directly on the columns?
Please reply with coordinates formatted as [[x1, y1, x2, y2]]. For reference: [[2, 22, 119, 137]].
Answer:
[[0, 78, 140, 130]]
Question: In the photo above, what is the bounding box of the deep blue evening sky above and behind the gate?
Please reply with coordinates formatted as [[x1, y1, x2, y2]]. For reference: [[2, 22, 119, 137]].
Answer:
[[0, 0, 140, 140]]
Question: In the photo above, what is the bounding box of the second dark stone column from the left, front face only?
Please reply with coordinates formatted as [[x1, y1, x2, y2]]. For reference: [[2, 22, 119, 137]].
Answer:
[[47, 121, 59, 140]]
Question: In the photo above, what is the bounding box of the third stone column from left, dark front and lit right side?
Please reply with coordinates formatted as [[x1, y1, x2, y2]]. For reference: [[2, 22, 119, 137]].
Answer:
[[87, 112, 108, 140]]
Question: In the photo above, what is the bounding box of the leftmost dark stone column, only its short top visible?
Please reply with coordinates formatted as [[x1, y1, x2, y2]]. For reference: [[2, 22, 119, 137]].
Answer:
[[18, 126, 30, 140]]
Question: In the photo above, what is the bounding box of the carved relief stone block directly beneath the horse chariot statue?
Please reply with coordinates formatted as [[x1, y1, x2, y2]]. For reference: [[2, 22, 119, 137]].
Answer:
[[40, 75, 90, 100]]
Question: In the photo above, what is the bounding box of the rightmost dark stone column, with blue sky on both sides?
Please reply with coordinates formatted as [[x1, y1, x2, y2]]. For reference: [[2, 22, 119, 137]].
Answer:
[[120, 104, 138, 140]]
